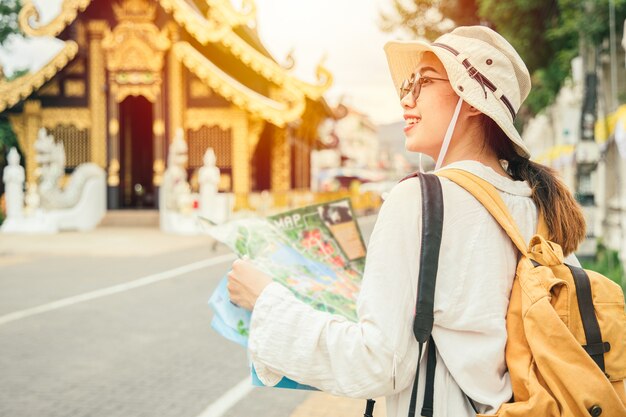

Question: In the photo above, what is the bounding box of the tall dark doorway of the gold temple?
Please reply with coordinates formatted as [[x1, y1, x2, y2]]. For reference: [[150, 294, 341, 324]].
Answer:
[[119, 96, 156, 208]]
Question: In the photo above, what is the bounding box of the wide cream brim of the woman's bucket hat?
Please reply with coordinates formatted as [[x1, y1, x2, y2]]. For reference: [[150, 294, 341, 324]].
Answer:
[[384, 40, 530, 158]]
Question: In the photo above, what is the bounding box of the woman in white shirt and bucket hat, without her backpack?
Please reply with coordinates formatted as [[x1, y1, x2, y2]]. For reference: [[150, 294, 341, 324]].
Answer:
[[229, 26, 585, 417]]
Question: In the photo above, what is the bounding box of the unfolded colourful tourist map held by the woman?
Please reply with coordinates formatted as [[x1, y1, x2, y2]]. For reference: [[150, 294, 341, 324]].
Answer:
[[208, 199, 365, 389]]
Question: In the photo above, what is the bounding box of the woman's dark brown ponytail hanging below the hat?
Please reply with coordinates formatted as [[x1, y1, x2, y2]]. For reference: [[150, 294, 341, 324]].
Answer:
[[483, 115, 586, 256]]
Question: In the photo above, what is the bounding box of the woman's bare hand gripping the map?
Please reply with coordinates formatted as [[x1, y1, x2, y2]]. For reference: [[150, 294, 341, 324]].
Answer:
[[227, 259, 272, 311]]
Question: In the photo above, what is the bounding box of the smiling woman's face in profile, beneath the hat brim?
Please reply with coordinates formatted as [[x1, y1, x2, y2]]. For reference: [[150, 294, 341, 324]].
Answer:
[[400, 52, 459, 159]]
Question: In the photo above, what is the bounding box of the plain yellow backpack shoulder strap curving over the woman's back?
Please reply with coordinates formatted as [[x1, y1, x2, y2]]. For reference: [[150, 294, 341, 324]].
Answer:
[[437, 169, 528, 255]]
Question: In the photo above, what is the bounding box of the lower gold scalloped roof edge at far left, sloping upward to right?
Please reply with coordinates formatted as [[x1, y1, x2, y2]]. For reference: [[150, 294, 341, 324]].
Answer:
[[0, 41, 78, 112]]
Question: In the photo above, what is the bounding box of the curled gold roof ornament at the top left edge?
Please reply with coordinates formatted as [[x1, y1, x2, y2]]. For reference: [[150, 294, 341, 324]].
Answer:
[[18, 0, 91, 37]]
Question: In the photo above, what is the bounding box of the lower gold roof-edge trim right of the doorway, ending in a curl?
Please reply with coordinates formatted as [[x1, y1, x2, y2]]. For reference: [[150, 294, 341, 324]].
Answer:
[[173, 42, 306, 127]]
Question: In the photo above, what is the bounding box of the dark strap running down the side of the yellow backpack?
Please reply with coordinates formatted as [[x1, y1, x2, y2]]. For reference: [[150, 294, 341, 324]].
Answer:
[[566, 264, 610, 372]]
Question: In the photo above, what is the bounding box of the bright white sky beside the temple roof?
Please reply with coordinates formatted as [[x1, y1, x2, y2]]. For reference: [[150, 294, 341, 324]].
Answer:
[[0, 0, 402, 124]]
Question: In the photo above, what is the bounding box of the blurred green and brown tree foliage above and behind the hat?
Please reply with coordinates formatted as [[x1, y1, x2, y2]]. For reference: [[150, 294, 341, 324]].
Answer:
[[380, 0, 626, 114]]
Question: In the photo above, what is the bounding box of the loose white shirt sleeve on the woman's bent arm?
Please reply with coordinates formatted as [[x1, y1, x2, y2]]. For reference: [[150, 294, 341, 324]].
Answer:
[[248, 179, 421, 398]]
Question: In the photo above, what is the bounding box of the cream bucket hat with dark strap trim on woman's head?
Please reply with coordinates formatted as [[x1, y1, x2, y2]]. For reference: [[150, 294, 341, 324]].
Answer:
[[385, 26, 530, 158]]
